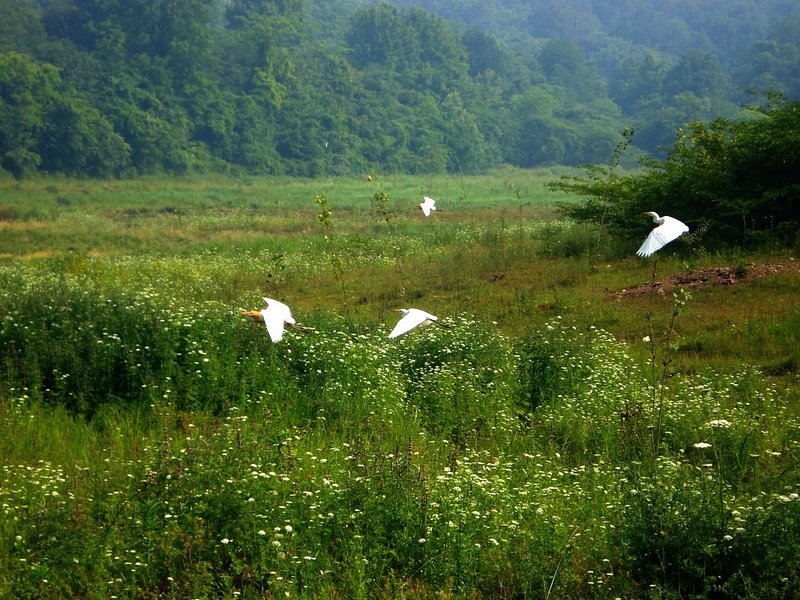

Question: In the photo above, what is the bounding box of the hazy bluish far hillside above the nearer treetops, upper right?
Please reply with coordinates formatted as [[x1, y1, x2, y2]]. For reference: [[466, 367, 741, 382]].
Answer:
[[368, 0, 797, 68]]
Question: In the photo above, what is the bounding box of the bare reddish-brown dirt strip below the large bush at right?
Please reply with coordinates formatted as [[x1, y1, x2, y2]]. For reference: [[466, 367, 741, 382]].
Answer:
[[610, 261, 800, 298]]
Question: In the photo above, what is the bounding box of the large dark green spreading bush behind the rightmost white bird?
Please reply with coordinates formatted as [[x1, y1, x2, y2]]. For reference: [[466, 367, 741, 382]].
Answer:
[[553, 97, 800, 247]]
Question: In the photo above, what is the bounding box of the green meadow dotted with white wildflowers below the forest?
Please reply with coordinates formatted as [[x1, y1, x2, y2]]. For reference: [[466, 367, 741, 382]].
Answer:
[[0, 168, 800, 600]]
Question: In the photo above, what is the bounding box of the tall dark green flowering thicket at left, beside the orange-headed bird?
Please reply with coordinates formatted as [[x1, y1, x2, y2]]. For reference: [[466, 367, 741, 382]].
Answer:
[[0, 268, 298, 417]]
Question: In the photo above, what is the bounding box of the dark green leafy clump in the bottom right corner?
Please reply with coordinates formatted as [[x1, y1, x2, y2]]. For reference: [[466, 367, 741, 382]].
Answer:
[[621, 460, 798, 598]]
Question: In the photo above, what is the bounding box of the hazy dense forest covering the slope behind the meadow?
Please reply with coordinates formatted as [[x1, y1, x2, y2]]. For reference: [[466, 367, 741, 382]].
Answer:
[[0, 0, 800, 178]]
